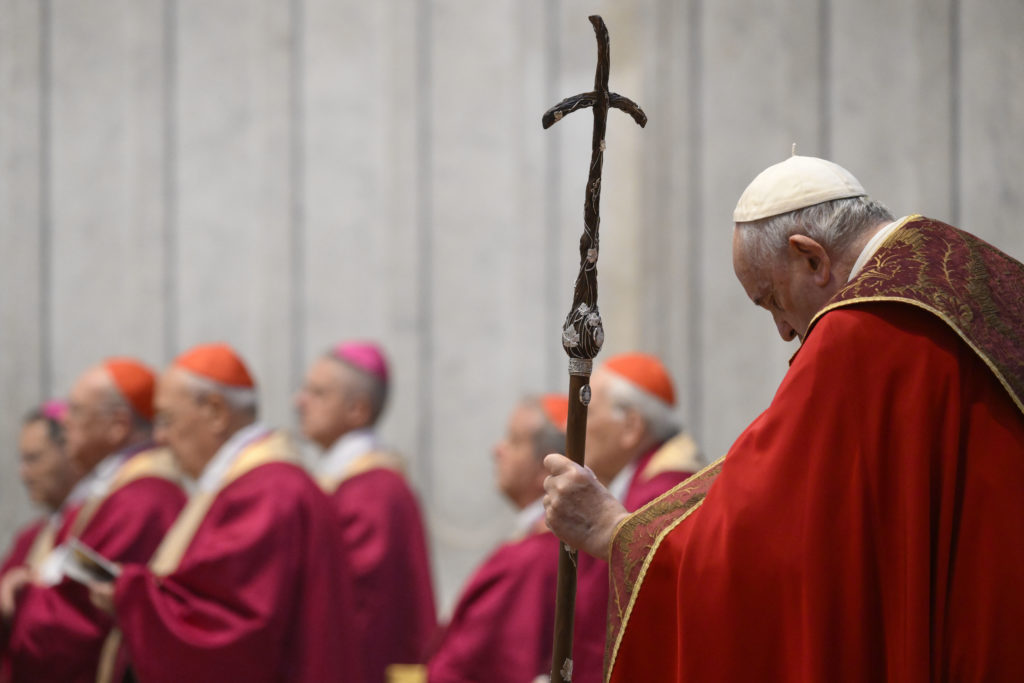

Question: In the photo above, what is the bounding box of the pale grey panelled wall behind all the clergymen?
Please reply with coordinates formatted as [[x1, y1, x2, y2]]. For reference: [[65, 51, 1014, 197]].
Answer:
[[0, 0, 1024, 606]]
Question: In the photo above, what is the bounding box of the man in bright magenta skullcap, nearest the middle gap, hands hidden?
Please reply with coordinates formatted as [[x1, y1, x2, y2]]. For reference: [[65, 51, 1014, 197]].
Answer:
[[295, 341, 437, 683]]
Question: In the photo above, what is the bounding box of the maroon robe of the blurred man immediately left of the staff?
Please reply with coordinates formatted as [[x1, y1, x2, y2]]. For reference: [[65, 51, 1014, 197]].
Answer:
[[427, 521, 558, 683]]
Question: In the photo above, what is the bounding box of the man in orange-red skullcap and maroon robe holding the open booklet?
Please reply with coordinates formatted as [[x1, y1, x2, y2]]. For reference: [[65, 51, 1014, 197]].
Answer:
[[91, 344, 364, 683]]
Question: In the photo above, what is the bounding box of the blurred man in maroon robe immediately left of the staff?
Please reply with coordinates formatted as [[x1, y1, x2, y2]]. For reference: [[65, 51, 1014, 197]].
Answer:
[[428, 394, 568, 683]]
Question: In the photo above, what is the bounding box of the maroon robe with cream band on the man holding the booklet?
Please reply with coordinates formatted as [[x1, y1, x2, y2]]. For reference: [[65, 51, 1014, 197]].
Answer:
[[114, 434, 364, 683]]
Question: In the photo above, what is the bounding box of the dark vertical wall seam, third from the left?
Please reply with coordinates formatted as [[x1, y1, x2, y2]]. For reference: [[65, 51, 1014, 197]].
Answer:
[[288, 0, 306, 387]]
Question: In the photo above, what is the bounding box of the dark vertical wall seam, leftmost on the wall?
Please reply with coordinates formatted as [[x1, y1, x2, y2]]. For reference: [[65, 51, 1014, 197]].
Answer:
[[39, 0, 53, 399]]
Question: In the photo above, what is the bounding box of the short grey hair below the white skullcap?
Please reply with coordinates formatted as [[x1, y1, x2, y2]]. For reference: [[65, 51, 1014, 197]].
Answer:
[[735, 196, 893, 263]]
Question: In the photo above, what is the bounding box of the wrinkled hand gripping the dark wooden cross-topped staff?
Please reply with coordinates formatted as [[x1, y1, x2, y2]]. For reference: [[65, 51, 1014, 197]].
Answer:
[[544, 453, 629, 560]]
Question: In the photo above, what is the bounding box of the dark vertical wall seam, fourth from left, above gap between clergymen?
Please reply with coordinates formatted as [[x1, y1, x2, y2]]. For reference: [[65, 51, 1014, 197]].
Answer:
[[416, 0, 434, 501]]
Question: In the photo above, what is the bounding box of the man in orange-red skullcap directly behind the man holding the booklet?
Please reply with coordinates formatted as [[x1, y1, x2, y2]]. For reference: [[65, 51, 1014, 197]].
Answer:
[[8, 358, 185, 683]]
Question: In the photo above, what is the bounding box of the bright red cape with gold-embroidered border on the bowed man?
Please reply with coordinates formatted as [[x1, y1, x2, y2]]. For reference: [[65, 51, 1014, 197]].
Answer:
[[608, 217, 1024, 683]]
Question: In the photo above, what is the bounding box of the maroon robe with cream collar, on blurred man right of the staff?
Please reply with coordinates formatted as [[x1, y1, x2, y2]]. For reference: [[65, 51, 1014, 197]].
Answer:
[[573, 433, 699, 683]]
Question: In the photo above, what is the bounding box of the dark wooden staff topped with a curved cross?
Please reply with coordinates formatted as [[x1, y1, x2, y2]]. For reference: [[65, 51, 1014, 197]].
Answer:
[[542, 14, 647, 683]]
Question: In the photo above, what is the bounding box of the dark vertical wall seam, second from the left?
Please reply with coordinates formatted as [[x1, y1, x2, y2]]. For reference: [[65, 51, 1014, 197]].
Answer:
[[163, 0, 178, 362]]
